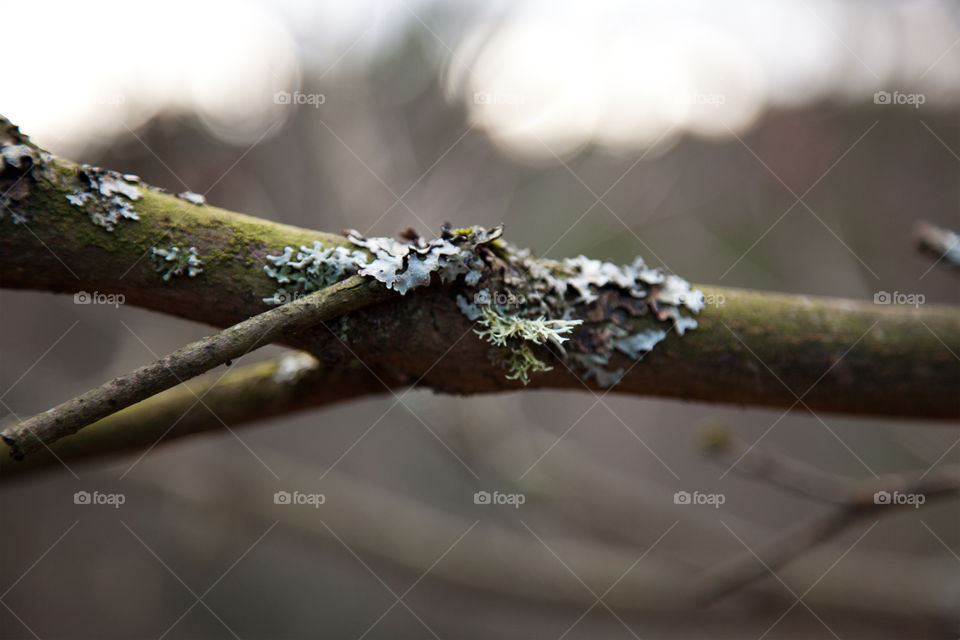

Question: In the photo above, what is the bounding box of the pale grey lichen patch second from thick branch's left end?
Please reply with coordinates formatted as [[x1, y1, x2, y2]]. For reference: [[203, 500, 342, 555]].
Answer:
[[65, 165, 141, 231]]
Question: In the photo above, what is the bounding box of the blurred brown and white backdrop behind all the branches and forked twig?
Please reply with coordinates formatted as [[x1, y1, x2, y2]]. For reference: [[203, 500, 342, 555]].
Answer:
[[0, 0, 960, 638]]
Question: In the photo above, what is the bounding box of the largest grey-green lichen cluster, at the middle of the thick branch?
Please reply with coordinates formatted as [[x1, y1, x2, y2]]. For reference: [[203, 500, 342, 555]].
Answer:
[[264, 222, 703, 387]]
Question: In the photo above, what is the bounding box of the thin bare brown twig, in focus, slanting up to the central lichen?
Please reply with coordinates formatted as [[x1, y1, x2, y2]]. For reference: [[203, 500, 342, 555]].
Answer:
[[0, 276, 396, 460]]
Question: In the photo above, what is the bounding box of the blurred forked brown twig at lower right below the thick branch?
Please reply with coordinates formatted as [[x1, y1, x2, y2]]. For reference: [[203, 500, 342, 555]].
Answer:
[[697, 425, 960, 605]]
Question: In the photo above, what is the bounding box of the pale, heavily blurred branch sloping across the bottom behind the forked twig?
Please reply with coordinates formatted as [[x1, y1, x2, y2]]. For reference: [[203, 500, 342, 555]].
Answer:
[[131, 448, 956, 619]]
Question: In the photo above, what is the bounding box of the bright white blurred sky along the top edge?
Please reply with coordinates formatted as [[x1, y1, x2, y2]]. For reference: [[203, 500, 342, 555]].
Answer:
[[0, 0, 960, 162]]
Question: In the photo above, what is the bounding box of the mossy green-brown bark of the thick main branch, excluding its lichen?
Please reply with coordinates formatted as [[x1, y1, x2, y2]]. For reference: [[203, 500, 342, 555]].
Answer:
[[0, 115, 960, 428]]
